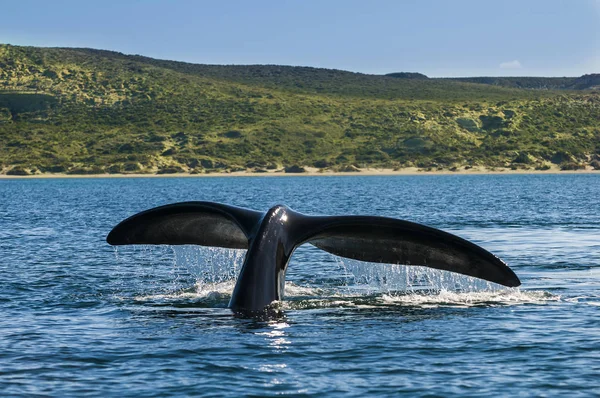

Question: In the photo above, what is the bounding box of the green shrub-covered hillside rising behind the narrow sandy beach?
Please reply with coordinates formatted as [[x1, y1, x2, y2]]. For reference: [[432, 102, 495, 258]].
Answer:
[[0, 45, 600, 174]]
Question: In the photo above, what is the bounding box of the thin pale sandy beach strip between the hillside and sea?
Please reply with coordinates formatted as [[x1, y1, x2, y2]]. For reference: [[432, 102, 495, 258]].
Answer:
[[0, 167, 600, 180]]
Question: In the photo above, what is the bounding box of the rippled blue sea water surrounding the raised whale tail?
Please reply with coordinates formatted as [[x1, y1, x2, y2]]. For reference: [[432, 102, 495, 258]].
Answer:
[[0, 174, 600, 397]]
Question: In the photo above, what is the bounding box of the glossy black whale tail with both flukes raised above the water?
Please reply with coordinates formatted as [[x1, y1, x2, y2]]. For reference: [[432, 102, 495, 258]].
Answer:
[[106, 202, 521, 311]]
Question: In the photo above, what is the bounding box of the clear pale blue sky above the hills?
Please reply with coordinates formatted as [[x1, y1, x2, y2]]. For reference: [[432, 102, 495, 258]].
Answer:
[[0, 0, 600, 76]]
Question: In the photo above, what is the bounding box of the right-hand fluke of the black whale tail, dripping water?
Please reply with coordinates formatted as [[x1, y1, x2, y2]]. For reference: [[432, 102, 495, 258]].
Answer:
[[309, 216, 521, 287]]
